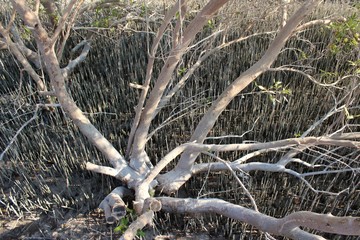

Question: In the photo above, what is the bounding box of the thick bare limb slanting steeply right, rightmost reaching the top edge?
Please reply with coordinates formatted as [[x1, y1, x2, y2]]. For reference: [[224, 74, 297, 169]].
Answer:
[[158, 0, 320, 192]]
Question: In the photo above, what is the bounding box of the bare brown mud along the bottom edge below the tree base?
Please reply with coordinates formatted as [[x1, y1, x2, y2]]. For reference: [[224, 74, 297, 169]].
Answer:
[[0, 209, 225, 240]]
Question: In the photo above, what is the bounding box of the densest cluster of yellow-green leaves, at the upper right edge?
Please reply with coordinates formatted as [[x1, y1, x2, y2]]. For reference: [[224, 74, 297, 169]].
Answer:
[[328, 14, 360, 54]]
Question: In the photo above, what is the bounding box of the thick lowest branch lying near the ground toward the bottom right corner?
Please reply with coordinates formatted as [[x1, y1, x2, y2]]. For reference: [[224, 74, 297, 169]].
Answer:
[[156, 197, 360, 239]]
